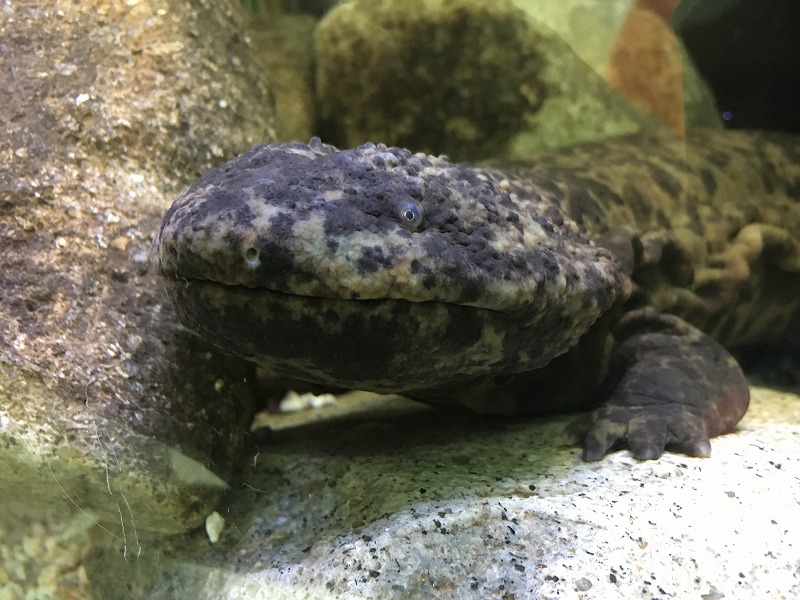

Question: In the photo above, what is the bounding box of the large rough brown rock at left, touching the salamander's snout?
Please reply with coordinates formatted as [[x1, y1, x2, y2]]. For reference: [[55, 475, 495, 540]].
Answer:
[[0, 0, 273, 536]]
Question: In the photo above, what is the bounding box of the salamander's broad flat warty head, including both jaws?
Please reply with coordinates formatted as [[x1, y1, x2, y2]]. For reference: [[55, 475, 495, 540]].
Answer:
[[154, 140, 625, 391]]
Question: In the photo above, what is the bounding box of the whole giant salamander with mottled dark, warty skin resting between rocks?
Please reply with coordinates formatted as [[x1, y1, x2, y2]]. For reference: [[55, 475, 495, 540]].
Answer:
[[154, 132, 800, 460]]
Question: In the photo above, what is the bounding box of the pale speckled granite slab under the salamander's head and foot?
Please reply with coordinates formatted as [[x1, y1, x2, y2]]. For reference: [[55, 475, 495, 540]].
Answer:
[[87, 388, 800, 599]]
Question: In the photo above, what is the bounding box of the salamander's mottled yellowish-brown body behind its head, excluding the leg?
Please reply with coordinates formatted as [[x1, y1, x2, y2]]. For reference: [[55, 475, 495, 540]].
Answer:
[[516, 131, 800, 347]]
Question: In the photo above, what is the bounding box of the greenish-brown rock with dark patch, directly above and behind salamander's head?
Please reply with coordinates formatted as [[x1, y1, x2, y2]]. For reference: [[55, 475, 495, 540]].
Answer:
[[315, 0, 660, 160]]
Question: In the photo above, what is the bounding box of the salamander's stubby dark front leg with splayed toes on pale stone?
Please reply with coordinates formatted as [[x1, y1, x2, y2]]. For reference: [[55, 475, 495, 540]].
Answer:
[[567, 309, 750, 461]]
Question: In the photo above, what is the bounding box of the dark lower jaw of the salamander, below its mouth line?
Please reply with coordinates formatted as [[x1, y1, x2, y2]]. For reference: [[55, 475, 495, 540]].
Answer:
[[165, 278, 574, 393]]
